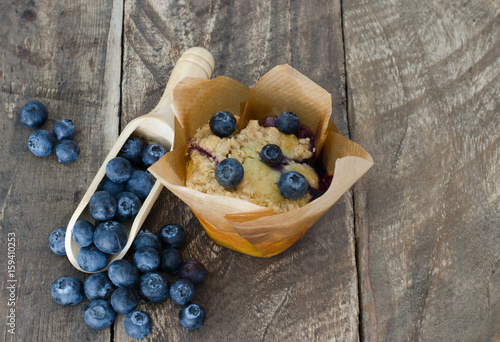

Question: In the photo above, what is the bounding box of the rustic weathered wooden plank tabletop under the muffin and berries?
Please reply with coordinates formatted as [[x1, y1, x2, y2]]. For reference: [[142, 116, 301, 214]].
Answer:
[[0, 0, 500, 341]]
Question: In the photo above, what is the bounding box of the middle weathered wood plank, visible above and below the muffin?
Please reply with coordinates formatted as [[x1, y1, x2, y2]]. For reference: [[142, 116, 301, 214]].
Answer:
[[114, 0, 358, 341]]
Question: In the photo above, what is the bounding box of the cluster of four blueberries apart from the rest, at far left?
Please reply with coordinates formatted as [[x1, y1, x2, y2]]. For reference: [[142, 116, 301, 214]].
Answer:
[[20, 101, 80, 164]]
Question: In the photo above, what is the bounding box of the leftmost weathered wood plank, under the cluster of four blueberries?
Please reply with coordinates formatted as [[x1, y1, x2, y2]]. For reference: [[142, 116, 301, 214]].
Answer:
[[0, 0, 122, 341]]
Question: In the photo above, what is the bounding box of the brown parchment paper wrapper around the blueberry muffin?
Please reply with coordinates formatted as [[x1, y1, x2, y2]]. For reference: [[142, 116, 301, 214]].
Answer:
[[149, 65, 373, 257]]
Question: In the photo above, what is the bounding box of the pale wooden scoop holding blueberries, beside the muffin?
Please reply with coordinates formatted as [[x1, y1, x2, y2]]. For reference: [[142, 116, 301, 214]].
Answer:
[[65, 47, 214, 273]]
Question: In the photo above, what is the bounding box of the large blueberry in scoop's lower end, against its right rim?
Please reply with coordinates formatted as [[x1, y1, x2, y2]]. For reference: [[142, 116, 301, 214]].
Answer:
[[94, 221, 127, 254]]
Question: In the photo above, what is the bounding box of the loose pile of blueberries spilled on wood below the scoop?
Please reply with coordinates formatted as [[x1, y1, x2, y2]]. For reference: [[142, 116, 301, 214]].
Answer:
[[51, 224, 207, 338]]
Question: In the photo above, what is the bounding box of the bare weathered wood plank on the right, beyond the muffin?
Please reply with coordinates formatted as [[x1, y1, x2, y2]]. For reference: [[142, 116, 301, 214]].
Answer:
[[343, 0, 500, 341]]
